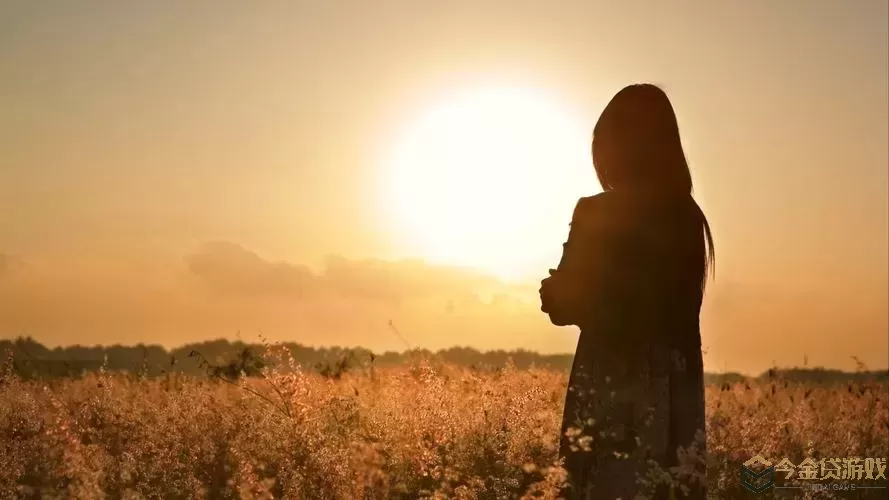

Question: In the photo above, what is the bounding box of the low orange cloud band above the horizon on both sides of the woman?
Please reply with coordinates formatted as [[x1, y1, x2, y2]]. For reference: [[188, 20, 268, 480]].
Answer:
[[0, 242, 889, 372]]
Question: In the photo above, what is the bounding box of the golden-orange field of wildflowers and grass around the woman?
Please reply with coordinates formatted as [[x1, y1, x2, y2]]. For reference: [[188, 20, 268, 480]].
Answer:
[[0, 348, 889, 499]]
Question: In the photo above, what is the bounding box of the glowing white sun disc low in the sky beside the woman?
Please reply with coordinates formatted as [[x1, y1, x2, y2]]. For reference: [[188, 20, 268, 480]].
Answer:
[[381, 87, 599, 279]]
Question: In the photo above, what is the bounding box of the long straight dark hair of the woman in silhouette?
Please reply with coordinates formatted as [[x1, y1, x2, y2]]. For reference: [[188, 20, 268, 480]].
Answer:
[[592, 83, 716, 287]]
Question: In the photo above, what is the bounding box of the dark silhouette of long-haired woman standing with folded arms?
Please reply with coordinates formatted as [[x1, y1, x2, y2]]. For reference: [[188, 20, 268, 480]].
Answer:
[[540, 84, 714, 500]]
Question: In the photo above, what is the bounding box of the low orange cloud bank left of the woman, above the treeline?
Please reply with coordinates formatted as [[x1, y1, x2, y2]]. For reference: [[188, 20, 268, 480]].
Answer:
[[0, 242, 556, 352]]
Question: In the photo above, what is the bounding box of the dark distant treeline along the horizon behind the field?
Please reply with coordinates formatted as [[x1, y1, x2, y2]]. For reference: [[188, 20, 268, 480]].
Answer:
[[0, 337, 889, 385]]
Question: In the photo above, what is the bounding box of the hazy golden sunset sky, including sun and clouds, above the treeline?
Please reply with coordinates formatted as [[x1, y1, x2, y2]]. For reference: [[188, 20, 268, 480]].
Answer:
[[0, 0, 889, 372]]
